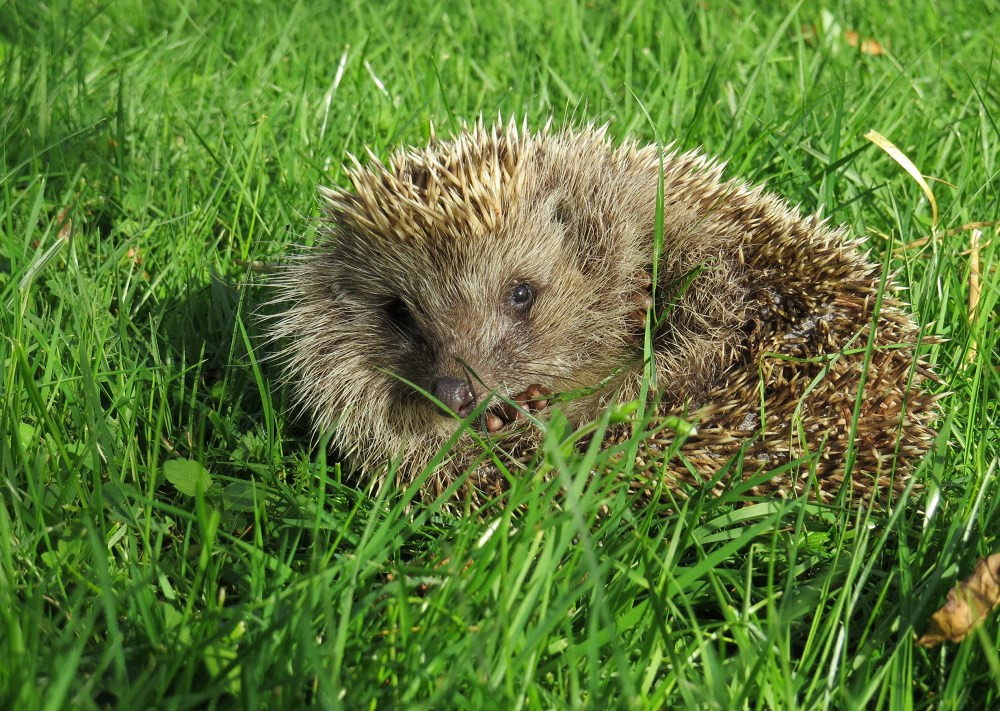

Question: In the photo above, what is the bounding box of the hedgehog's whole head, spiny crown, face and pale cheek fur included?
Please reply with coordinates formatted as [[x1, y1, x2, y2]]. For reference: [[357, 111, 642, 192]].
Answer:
[[272, 126, 672, 490]]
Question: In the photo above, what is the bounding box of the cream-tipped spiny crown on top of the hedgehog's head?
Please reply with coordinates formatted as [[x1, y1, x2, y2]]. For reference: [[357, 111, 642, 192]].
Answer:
[[322, 123, 656, 299]]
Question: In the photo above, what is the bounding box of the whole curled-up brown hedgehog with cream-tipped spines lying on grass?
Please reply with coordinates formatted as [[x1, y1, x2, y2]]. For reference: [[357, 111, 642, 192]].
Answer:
[[270, 122, 935, 506]]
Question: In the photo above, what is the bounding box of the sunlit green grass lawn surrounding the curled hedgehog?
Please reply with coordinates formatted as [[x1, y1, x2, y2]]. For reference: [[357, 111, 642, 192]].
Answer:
[[0, 0, 1000, 709]]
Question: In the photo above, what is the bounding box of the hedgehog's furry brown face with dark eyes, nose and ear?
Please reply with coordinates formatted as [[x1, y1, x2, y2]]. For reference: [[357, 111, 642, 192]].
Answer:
[[329, 191, 640, 436]]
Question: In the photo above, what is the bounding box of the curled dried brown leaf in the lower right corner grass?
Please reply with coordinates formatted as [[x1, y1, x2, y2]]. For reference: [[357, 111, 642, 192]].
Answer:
[[917, 553, 1000, 647]]
